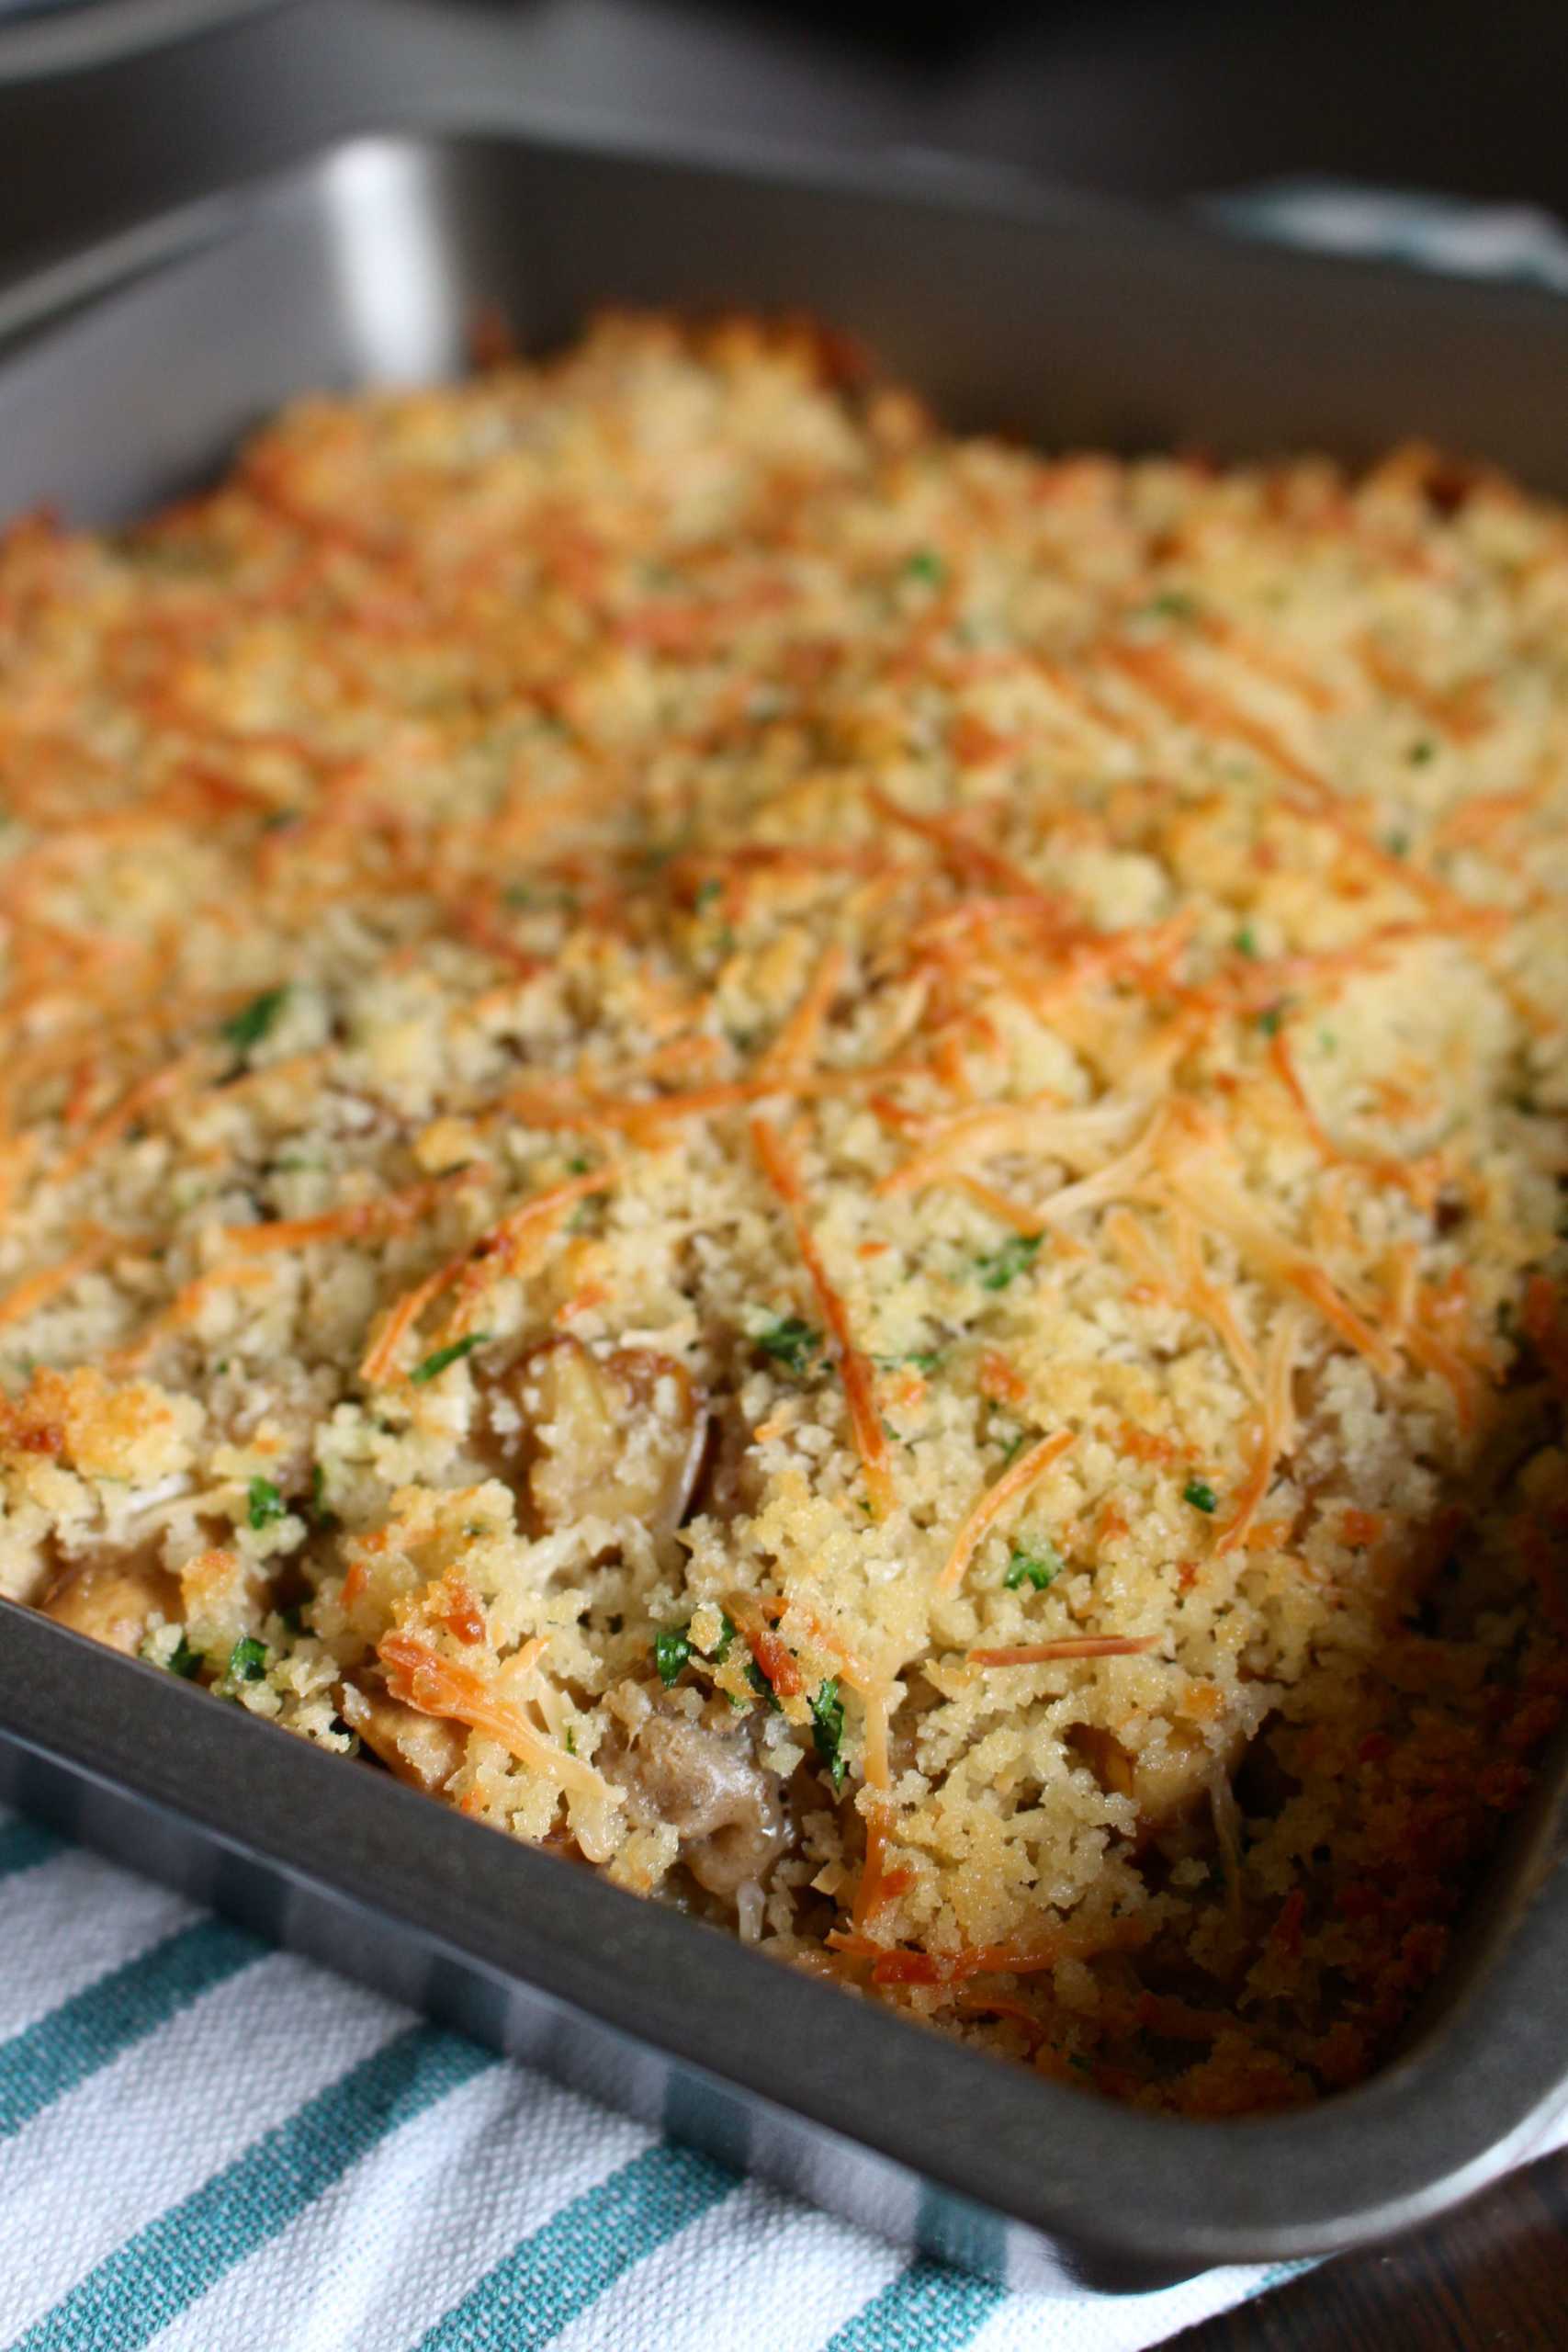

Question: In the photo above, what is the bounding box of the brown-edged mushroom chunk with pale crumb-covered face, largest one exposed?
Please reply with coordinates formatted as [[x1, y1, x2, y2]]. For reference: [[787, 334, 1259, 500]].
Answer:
[[508, 1339, 707, 1536]]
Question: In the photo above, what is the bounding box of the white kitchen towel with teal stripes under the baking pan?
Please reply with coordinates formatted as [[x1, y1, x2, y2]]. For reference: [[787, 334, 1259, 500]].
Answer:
[[0, 184, 1568, 2352]]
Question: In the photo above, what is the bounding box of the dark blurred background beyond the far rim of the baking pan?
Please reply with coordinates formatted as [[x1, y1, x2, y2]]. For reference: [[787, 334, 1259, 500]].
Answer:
[[0, 0, 1568, 288]]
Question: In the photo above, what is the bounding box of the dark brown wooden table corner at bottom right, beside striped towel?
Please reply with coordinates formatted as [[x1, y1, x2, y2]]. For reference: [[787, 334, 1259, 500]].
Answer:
[[1170, 2152, 1568, 2352]]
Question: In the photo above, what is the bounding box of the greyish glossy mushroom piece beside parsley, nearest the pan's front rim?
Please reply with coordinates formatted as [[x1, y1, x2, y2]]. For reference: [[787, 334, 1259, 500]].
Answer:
[[621, 1713, 787, 1903]]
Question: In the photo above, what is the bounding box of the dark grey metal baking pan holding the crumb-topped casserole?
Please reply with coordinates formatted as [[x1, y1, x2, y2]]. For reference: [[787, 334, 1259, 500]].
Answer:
[[0, 127, 1568, 2289]]
